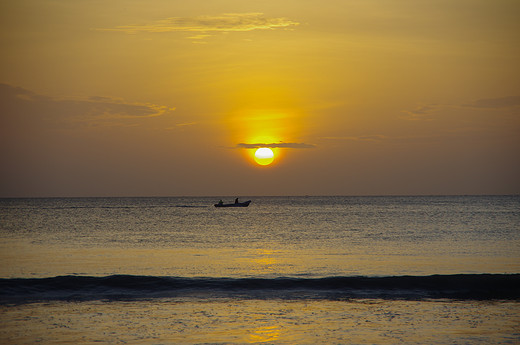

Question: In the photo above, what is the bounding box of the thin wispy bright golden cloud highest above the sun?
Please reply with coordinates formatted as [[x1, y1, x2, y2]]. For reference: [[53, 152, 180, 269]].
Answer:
[[99, 13, 299, 35]]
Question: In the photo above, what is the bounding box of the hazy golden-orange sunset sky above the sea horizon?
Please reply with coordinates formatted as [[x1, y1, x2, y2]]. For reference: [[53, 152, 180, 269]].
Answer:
[[0, 0, 520, 197]]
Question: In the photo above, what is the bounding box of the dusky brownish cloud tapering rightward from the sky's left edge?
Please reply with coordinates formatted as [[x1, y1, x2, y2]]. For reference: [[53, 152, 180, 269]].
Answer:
[[0, 84, 174, 125]]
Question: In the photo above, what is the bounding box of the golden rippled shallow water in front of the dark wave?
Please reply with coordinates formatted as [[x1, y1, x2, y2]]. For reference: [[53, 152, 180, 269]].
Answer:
[[0, 298, 520, 344]]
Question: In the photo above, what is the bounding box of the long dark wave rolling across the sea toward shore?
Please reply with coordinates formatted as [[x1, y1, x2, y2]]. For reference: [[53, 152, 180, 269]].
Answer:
[[0, 274, 520, 304]]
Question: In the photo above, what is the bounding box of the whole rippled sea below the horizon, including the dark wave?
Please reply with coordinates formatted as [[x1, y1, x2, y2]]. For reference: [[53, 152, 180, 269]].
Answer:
[[0, 196, 520, 344]]
